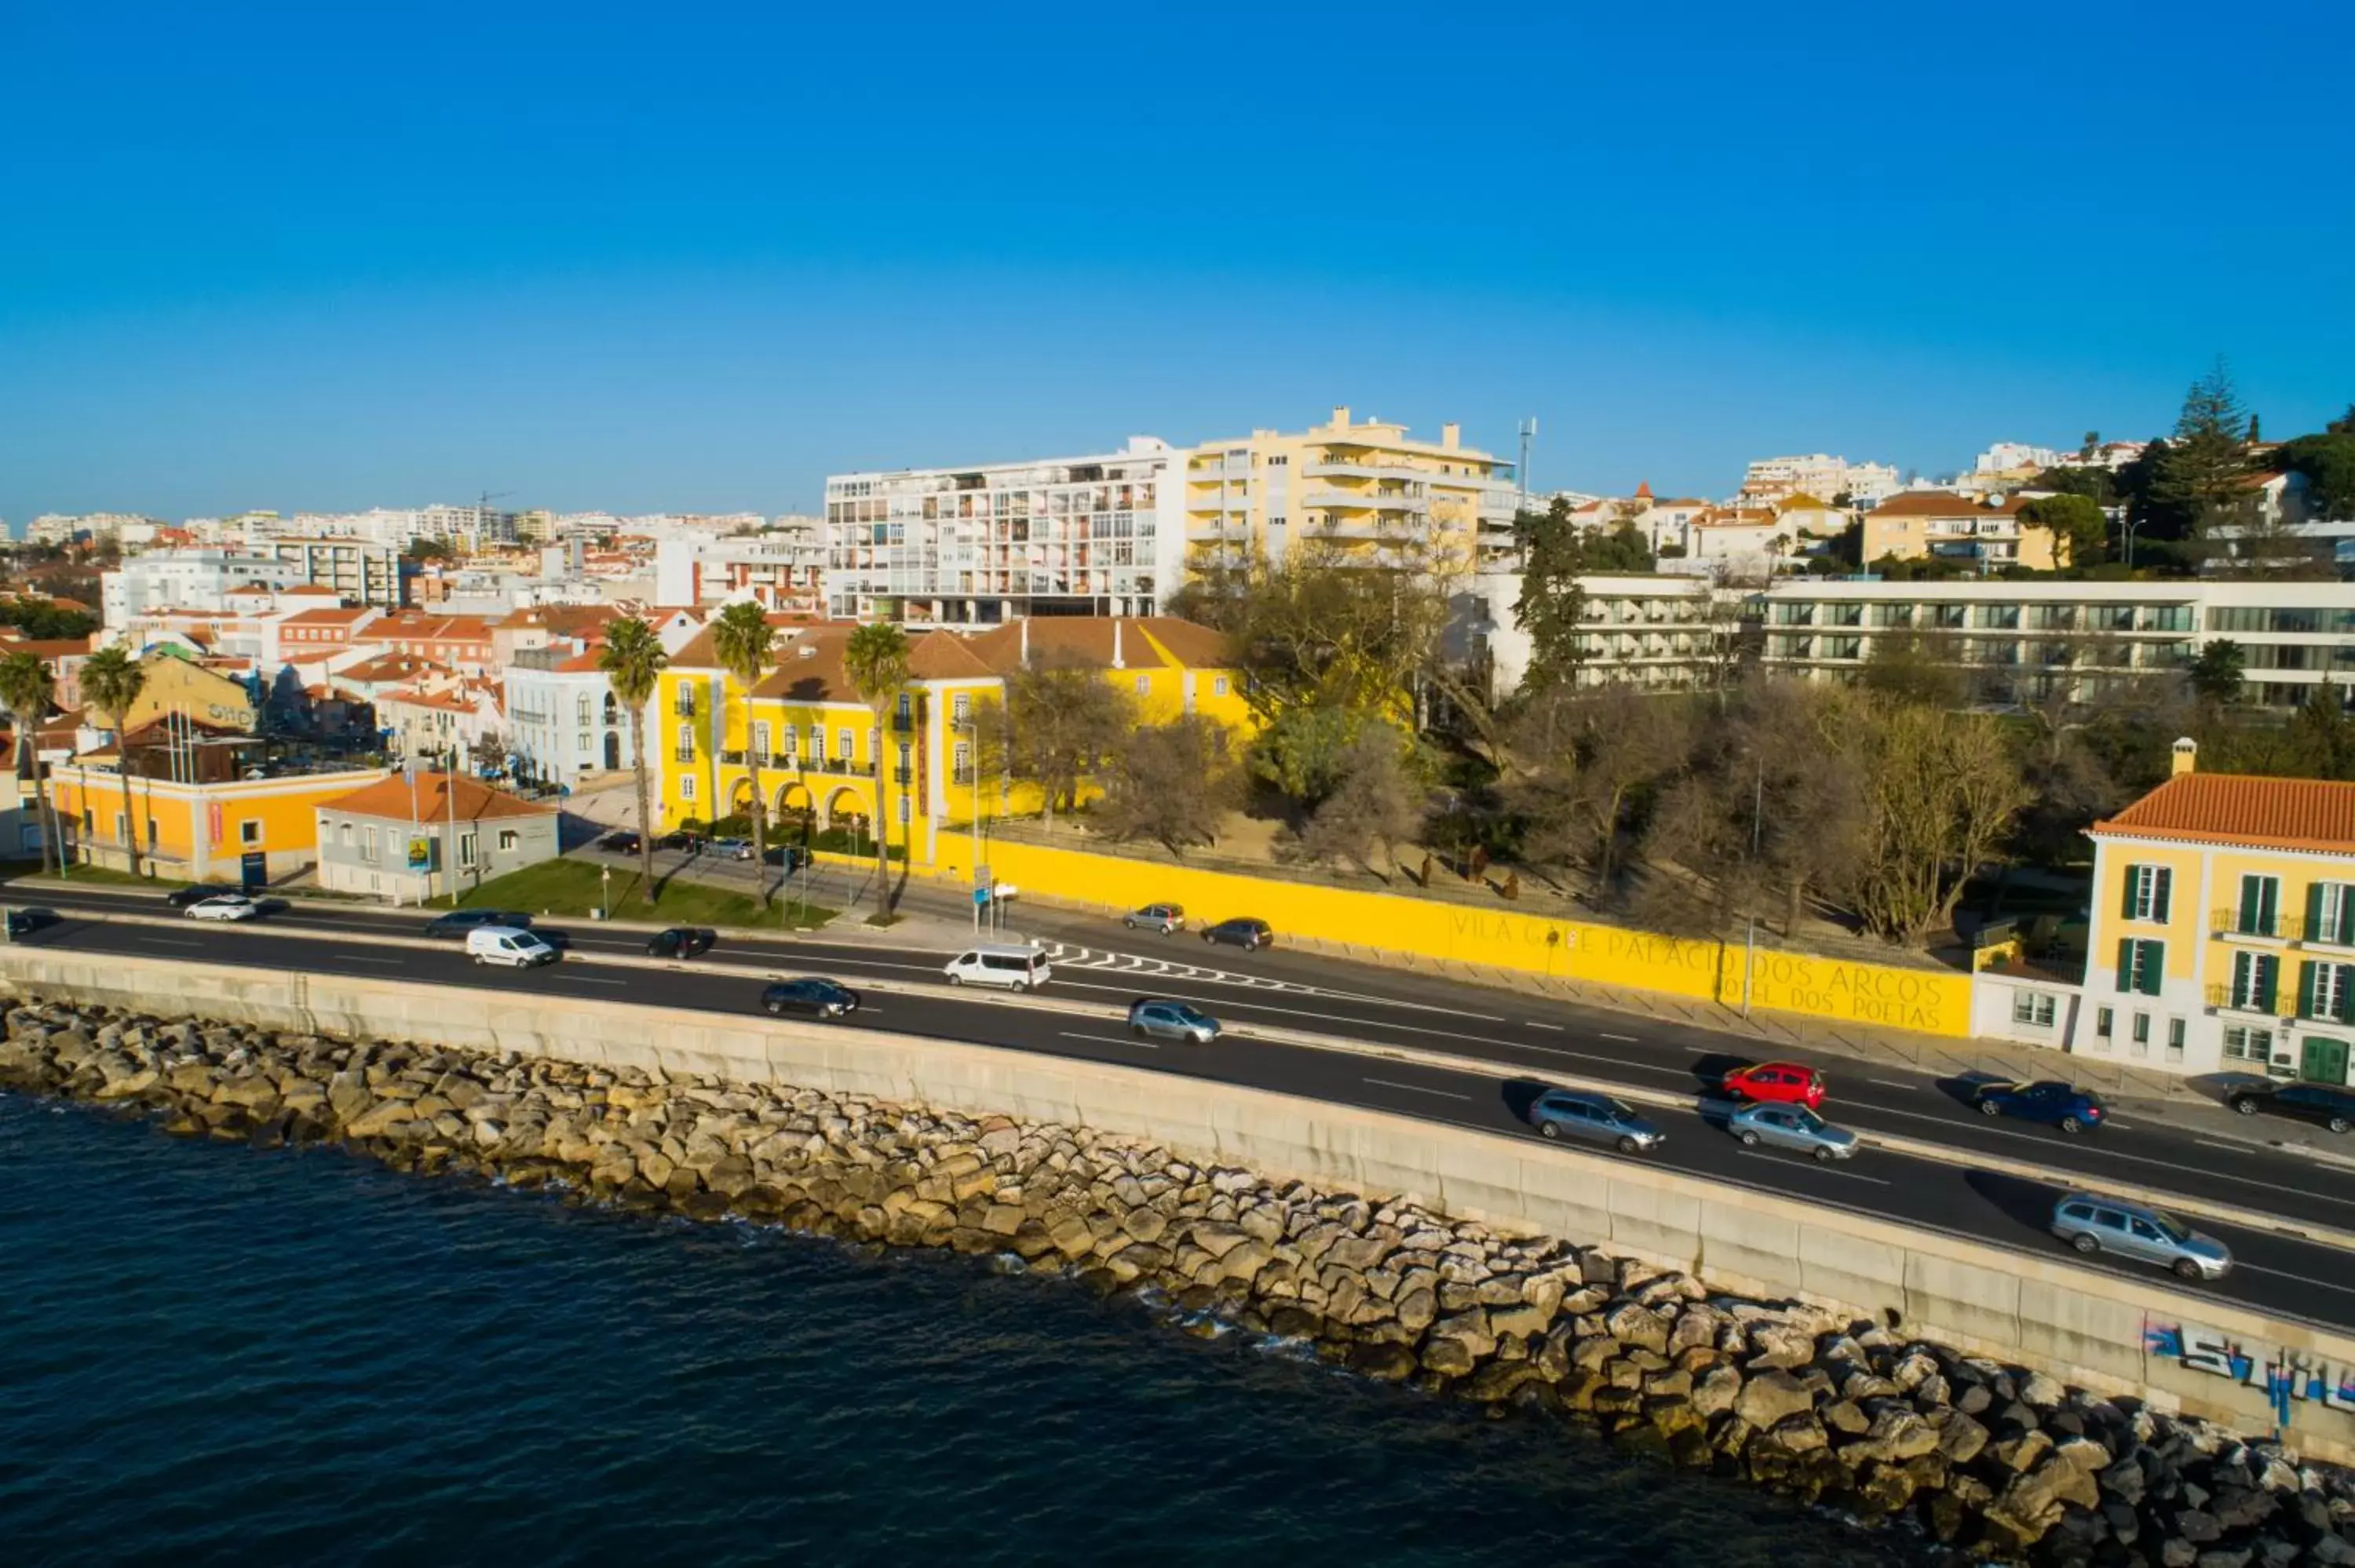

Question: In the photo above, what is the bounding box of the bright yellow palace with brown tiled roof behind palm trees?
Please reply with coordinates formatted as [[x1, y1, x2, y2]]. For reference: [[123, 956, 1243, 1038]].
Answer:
[[645, 617, 1251, 864]]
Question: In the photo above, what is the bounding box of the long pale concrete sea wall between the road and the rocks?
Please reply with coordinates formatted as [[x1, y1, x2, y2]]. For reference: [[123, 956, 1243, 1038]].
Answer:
[[18, 946, 2355, 1462]]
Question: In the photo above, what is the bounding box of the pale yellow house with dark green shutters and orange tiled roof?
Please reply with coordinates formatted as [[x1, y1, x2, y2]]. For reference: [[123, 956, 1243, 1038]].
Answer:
[[2072, 739, 2355, 1083]]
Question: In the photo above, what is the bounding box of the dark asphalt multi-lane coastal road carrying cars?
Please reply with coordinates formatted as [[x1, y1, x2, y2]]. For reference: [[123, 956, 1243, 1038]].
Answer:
[[24, 871, 2355, 1328]]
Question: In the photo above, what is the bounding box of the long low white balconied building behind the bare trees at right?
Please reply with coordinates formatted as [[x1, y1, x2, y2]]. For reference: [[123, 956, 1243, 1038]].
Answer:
[[1455, 572, 2355, 709]]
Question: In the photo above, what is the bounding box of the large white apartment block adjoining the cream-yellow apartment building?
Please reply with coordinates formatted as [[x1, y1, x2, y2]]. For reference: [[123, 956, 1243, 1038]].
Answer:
[[834, 436, 1185, 624]]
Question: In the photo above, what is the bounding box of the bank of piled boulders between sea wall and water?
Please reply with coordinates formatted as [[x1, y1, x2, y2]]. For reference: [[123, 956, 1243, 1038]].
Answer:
[[0, 1005, 2355, 1568]]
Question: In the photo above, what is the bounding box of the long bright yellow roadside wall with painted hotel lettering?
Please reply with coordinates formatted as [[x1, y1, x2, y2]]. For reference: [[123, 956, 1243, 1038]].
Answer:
[[933, 833, 1971, 1038]]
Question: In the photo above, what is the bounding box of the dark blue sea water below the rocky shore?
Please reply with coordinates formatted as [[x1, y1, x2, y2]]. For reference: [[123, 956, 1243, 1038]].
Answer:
[[0, 1097, 1915, 1568]]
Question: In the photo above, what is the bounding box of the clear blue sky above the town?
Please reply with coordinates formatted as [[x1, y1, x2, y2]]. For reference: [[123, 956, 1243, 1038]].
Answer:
[[0, 0, 2355, 527]]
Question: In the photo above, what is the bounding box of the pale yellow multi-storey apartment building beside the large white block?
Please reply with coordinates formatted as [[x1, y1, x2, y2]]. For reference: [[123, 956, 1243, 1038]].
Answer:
[[1182, 407, 1517, 574]]
